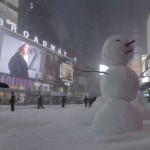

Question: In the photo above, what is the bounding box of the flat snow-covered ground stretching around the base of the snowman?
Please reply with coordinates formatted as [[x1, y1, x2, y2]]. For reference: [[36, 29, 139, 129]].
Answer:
[[0, 105, 150, 150]]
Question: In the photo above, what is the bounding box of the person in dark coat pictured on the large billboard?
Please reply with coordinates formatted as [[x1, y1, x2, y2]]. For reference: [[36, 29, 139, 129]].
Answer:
[[8, 43, 29, 78]]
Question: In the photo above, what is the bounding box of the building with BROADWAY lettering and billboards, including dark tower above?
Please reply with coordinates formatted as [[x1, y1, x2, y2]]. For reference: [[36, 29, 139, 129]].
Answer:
[[0, 0, 87, 104]]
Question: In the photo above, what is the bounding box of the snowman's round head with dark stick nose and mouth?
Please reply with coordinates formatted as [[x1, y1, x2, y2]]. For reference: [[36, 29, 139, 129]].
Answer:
[[101, 35, 134, 66]]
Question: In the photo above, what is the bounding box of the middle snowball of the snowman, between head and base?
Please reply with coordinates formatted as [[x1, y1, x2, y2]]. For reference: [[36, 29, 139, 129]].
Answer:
[[101, 65, 139, 102]]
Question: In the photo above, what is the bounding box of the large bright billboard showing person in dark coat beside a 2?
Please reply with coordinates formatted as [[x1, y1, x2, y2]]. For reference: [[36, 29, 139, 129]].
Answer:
[[0, 31, 46, 80]]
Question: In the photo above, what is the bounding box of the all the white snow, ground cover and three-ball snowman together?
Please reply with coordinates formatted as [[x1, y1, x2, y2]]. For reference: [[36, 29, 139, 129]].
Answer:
[[0, 35, 146, 150]]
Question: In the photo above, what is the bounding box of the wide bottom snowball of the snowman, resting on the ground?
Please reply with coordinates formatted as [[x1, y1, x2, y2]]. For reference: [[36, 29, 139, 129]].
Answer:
[[93, 100, 143, 135]]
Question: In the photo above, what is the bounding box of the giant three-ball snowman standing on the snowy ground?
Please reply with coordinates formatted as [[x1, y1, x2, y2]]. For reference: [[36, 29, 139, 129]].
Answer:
[[93, 35, 142, 135]]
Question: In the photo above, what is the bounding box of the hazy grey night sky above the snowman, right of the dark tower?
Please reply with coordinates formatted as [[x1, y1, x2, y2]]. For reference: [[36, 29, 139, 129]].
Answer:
[[49, 0, 150, 68]]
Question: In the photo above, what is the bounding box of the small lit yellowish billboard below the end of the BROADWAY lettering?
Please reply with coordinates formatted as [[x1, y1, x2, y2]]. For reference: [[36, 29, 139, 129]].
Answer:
[[60, 63, 73, 83]]
